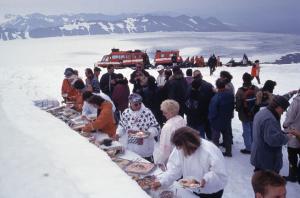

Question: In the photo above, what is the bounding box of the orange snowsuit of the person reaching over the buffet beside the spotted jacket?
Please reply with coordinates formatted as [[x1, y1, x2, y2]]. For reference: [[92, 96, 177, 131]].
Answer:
[[82, 101, 117, 138]]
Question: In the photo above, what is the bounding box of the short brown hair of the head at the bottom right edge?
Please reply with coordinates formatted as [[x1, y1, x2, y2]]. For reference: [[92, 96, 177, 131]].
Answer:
[[251, 170, 286, 195]]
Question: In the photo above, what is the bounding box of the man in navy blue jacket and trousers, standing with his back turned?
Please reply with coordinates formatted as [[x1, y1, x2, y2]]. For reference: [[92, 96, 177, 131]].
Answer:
[[208, 78, 234, 157]]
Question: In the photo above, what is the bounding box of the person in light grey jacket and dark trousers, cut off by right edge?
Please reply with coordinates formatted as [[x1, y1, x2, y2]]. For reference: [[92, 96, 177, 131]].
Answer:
[[283, 92, 300, 182]]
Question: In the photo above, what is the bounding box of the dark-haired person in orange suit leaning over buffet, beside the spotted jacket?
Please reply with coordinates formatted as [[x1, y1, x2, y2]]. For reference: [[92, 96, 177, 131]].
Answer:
[[82, 95, 117, 138]]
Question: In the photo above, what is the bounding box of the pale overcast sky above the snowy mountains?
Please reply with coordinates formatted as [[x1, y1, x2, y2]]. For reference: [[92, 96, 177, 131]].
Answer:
[[0, 0, 300, 32]]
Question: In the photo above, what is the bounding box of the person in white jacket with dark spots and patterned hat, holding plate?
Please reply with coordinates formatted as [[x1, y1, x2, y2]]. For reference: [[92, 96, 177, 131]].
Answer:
[[116, 93, 160, 162]]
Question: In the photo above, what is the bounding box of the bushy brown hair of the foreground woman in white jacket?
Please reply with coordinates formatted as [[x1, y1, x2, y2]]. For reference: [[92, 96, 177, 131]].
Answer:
[[171, 127, 200, 156]]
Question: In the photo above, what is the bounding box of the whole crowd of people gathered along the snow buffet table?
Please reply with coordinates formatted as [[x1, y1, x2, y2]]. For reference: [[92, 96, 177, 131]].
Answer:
[[61, 62, 300, 198]]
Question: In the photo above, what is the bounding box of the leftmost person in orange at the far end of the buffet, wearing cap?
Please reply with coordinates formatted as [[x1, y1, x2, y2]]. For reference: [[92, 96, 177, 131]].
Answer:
[[61, 67, 77, 102]]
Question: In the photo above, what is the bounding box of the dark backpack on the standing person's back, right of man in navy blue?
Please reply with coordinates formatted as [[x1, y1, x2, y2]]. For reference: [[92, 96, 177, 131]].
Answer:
[[243, 85, 256, 117]]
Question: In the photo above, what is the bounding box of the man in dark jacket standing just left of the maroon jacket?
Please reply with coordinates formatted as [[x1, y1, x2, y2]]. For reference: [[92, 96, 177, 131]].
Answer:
[[100, 65, 116, 97]]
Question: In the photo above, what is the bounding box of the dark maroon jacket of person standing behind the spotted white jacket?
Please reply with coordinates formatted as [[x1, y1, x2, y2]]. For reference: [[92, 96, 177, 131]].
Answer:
[[111, 79, 130, 112]]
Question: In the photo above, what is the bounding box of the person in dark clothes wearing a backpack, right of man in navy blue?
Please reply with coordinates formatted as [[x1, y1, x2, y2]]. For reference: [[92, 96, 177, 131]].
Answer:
[[235, 72, 259, 154]]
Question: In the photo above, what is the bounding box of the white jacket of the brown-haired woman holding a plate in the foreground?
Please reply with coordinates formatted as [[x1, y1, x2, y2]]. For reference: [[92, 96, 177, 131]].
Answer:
[[159, 139, 227, 194]]
